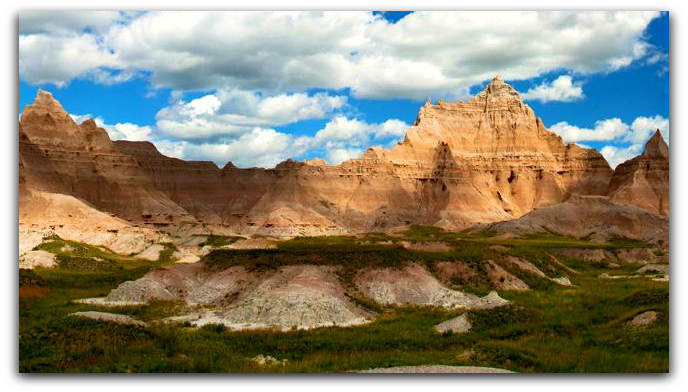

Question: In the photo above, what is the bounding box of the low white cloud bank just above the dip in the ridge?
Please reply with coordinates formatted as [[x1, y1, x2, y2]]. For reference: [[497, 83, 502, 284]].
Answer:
[[72, 91, 400, 167]]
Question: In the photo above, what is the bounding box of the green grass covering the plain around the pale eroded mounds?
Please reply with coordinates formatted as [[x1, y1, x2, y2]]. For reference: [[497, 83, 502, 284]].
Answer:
[[19, 234, 669, 372]]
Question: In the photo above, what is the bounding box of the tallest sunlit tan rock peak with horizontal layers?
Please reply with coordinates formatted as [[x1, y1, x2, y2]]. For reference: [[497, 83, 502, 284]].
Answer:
[[366, 77, 612, 227]]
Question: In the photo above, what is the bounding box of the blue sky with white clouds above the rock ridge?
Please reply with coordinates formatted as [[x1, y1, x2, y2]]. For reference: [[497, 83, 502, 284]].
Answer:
[[19, 11, 669, 167]]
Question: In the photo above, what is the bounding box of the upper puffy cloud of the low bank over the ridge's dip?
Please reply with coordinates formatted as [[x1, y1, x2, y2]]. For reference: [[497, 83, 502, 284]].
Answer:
[[156, 90, 347, 140]]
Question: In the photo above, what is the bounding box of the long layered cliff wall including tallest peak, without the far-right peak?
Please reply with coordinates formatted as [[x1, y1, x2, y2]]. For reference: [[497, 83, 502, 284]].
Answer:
[[19, 78, 620, 236]]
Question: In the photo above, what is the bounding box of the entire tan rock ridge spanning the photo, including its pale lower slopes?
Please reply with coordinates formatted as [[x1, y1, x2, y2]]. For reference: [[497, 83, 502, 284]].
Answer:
[[19, 77, 669, 254]]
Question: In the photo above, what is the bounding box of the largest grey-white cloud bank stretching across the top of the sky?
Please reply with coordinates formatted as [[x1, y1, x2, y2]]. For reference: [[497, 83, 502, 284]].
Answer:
[[19, 12, 661, 99]]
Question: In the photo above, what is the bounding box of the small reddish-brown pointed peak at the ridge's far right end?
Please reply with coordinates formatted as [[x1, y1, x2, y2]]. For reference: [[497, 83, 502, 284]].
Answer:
[[609, 130, 669, 215]]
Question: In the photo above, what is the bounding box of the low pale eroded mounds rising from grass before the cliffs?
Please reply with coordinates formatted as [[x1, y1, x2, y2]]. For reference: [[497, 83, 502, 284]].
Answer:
[[95, 262, 508, 330]]
